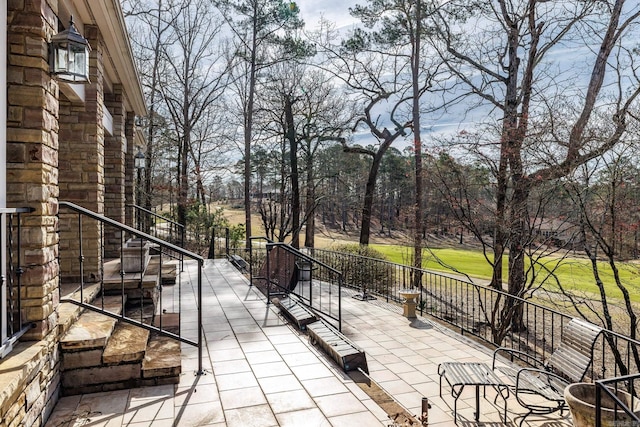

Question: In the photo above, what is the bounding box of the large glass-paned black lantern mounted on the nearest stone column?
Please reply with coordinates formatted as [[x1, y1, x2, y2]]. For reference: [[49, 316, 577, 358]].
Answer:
[[49, 18, 91, 83]]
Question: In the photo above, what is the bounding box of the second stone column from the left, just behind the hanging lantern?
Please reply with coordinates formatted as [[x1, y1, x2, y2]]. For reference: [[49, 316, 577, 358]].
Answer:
[[60, 25, 105, 282]]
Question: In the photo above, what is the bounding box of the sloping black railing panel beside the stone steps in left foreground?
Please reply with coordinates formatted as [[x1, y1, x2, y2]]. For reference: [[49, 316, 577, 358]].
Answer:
[[59, 202, 204, 373]]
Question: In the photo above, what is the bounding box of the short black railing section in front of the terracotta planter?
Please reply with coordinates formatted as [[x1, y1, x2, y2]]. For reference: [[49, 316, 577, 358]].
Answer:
[[587, 374, 640, 427]]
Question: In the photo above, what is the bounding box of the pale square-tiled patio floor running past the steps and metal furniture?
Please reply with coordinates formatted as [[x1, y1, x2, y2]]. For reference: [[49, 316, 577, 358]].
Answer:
[[46, 260, 571, 427]]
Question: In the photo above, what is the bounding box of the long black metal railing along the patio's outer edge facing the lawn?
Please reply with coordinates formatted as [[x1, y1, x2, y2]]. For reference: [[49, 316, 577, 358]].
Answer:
[[309, 249, 640, 379]]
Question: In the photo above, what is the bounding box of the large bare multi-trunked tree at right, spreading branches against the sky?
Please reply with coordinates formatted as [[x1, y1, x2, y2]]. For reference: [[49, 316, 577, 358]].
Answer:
[[433, 0, 640, 330]]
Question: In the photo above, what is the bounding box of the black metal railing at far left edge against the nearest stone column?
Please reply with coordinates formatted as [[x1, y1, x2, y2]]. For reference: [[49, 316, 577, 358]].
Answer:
[[0, 208, 33, 359]]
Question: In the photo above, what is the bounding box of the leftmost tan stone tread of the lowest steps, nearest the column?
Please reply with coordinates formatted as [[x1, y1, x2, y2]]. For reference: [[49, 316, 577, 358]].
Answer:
[[60, 296, 122, 351]]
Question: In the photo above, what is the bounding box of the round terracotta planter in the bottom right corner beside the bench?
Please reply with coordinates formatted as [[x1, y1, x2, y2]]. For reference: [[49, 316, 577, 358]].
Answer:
[[564, 383, 640, 427]]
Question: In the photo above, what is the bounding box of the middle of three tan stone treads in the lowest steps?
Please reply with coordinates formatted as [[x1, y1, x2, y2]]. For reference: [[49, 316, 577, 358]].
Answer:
[[102, 322, 149, 365]]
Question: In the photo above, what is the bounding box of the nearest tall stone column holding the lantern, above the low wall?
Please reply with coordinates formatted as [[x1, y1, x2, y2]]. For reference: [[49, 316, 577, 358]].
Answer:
[[6, 0, 58, 340]]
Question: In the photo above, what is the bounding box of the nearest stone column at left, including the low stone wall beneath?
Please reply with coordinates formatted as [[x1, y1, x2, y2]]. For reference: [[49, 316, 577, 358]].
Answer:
[[5, 0, 60, 426]]
